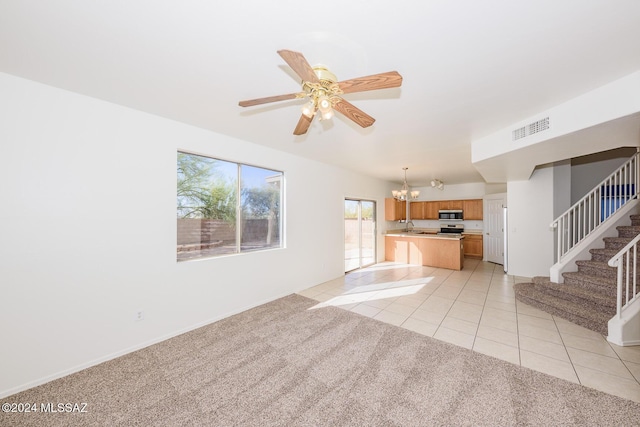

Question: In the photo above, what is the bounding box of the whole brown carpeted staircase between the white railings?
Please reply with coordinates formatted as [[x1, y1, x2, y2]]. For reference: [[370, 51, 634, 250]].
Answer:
[[514, 215, 640, 335]]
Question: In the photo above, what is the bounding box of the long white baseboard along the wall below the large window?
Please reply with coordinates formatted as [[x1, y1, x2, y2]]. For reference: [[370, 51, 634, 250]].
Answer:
[[0, 292, 293, 398]]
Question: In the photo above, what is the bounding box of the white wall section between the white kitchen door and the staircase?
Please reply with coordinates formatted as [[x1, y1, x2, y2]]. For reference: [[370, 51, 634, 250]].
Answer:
[[507, 166, 555, 277]]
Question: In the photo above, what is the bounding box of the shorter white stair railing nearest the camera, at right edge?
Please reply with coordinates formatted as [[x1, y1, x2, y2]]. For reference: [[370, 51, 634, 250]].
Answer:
[[608, 234, 640, 318]]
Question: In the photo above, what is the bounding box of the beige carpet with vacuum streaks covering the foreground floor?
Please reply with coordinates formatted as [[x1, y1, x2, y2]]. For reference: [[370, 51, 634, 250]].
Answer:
[[5, 295, 640, 427]]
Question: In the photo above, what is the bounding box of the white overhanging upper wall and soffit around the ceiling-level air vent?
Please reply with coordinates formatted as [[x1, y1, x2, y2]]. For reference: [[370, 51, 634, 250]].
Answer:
[[471, 70, 640, 182]]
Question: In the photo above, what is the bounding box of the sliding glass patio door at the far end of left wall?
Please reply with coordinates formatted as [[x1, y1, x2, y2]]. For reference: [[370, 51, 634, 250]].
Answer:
[[344, 199, 376, 272]]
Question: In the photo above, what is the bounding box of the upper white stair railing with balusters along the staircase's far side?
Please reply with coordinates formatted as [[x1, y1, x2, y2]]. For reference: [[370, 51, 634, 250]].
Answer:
[[551, 153, 640, 262]]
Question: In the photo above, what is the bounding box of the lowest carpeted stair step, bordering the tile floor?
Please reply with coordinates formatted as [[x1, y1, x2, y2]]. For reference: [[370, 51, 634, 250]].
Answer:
[[513, 283, 613, 335]]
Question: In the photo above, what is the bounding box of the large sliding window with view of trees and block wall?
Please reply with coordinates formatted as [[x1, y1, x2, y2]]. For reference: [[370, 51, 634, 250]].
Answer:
[[177, 151, 283, 261]]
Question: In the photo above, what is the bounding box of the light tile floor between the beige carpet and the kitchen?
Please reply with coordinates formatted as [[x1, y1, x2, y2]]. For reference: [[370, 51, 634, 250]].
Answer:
[[299, 259, 640, 402]]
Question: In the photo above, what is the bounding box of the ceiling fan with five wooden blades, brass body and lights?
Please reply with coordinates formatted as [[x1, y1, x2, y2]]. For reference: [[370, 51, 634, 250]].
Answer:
[[238, 50, 402, 135]]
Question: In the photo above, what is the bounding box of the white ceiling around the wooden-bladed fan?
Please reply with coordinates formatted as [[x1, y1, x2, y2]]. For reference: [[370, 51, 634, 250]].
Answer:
[[0, 0, 640, 186]]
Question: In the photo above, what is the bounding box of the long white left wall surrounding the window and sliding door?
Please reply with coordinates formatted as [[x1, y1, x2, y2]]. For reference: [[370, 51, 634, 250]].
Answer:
[[0, 73, 390, 396]]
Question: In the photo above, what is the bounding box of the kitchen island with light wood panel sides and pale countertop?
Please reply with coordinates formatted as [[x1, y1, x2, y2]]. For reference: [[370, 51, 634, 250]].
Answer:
[[384, 231, 464, 270]]
